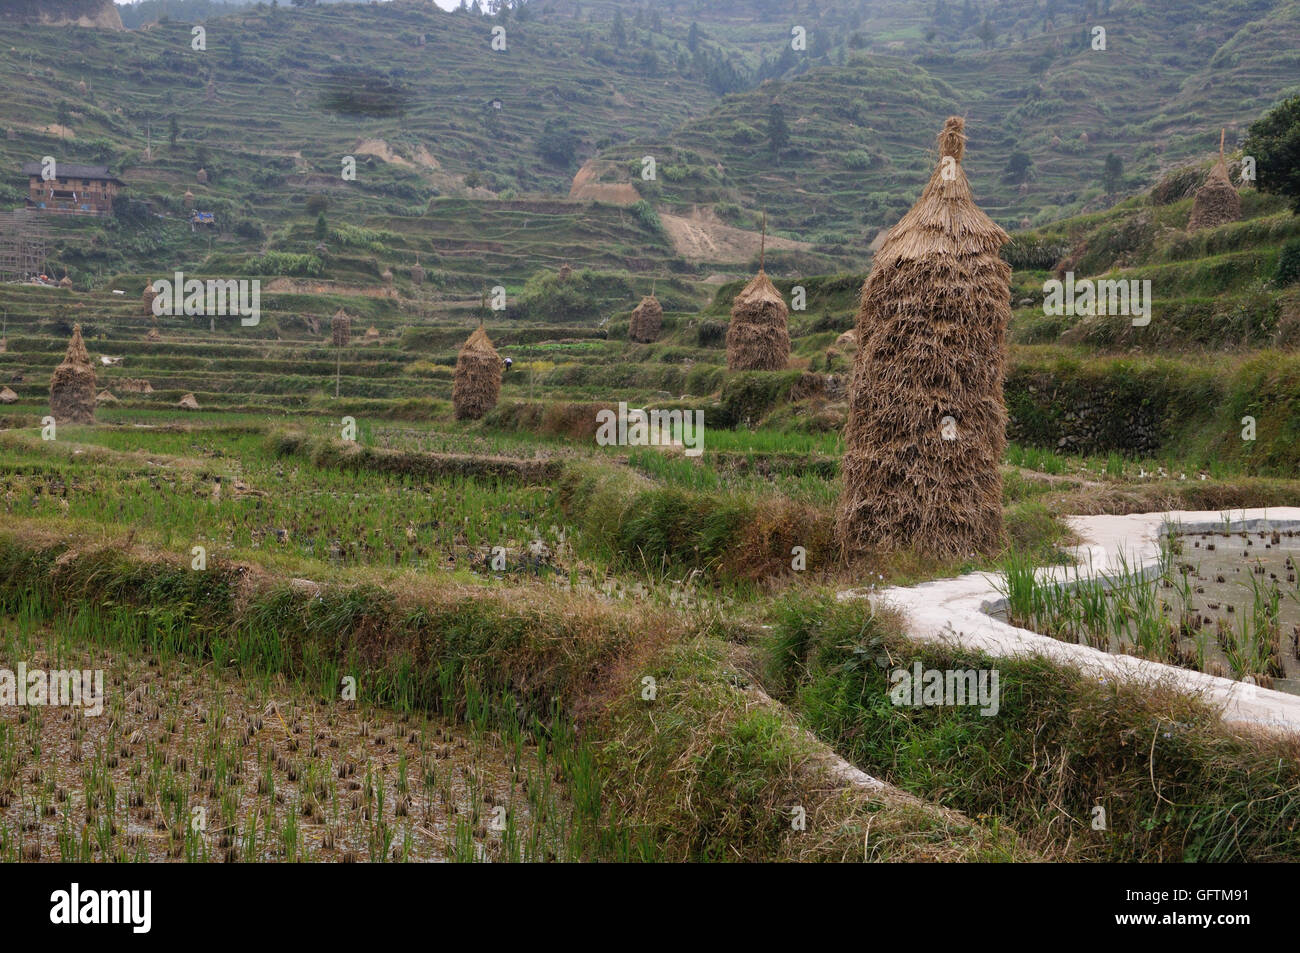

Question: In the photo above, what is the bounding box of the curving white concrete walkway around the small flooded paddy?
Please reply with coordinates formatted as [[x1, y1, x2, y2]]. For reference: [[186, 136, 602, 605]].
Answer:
[[840, 507, 1300, 732]]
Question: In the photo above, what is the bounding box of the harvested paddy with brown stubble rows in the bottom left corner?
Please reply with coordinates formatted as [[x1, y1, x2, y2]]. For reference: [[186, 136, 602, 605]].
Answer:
[[0, 619, 566, 862]]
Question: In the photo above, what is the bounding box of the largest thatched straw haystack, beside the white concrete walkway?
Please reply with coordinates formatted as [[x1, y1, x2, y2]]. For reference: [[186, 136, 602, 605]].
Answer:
[[836, 117, 1011, 558]]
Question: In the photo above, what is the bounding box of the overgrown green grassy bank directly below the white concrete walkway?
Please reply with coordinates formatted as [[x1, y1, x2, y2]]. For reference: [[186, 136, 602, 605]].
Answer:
[[766, 597, 1297, 862]]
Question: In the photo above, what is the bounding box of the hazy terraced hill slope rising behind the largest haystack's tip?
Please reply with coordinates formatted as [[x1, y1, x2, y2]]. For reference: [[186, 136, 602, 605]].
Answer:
[[602, 0, 1300, 249]]
